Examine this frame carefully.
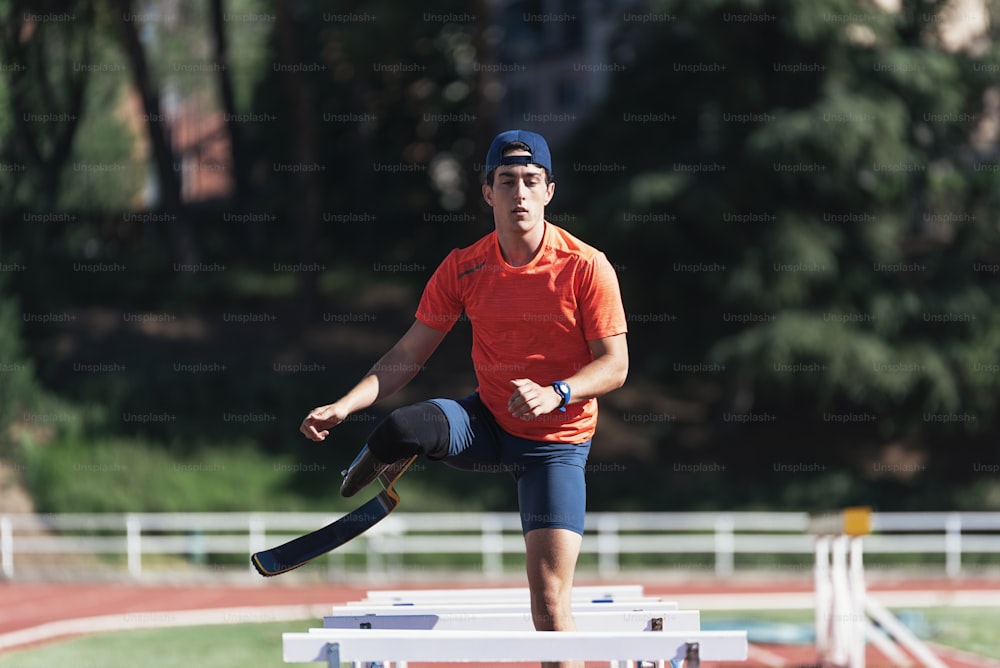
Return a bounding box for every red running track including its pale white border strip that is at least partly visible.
[0,579,1000,668]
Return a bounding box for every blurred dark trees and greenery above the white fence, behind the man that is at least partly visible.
[0,0,1000,536]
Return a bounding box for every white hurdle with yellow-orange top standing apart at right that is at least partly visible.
[809,507,947,668]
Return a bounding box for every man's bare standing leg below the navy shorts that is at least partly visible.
[524,529,583,668]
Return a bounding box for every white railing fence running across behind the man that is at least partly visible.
[0,512,1000,578]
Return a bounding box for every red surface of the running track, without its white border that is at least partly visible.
[0,580,1000,668]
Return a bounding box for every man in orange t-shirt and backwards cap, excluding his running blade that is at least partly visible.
[301,130,628,666]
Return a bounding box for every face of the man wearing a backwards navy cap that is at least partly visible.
[483,151,556,232]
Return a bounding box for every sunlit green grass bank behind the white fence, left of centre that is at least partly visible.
[19,428,516,513]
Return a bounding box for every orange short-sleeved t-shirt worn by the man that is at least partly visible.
[416,222,627,443]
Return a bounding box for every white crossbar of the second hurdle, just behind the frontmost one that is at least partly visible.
[323,608,701,632]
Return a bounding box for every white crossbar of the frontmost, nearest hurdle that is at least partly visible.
[282,629,748,668]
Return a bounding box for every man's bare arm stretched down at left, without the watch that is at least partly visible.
[299,320,447,441]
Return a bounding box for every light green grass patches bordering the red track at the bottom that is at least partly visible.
[0,608,1000,668]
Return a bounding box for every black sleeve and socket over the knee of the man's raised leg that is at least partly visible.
[368,401,451,464]
